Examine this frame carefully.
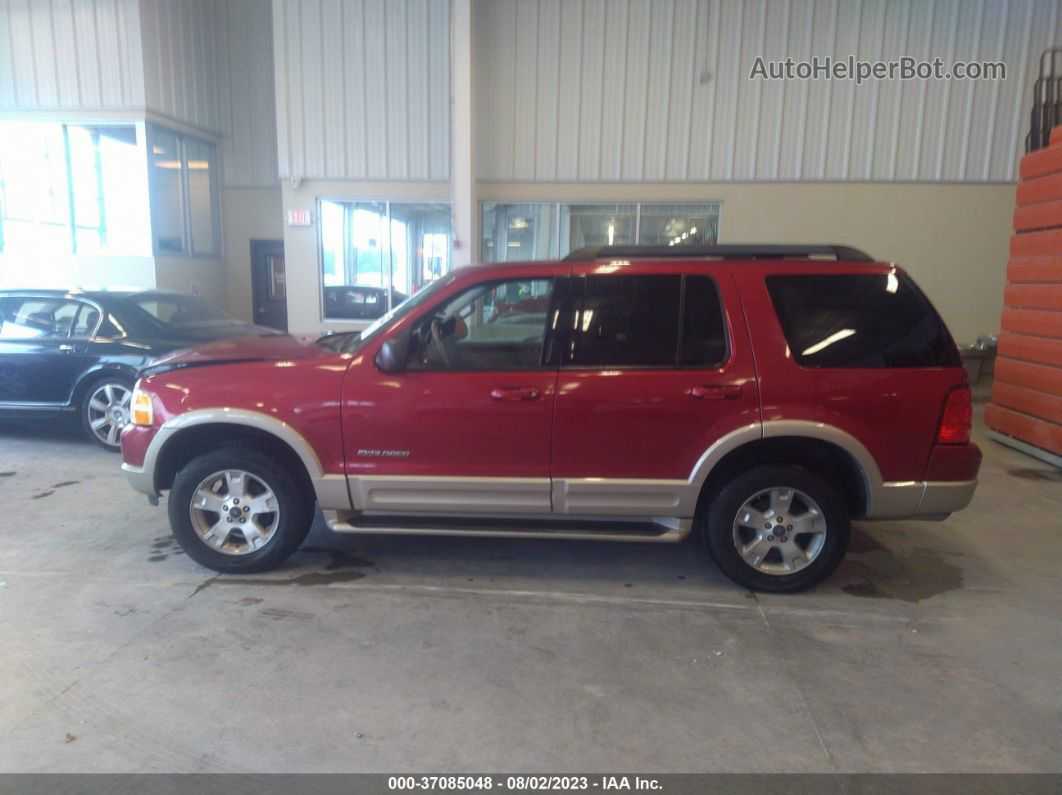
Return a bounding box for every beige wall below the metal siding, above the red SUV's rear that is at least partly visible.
[479,183,1014,343]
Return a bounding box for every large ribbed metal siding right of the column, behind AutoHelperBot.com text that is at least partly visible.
[476,0,1062,182]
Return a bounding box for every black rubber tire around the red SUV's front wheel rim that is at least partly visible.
[167,445,314,574]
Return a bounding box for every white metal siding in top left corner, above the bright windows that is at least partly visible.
[0,0,144,110]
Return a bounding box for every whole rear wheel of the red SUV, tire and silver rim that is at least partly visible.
[705,466,851,592]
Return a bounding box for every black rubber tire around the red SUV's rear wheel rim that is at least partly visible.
[703,466,852,593]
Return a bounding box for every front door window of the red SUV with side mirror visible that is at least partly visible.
[407,279,553,370]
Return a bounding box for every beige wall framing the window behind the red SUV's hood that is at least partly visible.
[284,179,450,333]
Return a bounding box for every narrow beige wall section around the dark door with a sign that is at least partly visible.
[221,186,290,321]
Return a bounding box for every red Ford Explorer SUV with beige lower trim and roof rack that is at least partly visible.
[122,245,981,591]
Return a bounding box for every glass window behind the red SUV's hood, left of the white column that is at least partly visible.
[319,200,453,321]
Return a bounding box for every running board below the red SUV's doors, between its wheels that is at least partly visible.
[323,511,693,542]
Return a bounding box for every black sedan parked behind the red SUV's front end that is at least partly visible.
[0,290,278,451]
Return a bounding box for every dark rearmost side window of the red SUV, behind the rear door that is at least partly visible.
[767,274,959,367]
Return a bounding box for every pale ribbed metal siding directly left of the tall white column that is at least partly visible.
[273,0,450,179]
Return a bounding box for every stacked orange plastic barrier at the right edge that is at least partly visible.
[984,126,1062,456]
